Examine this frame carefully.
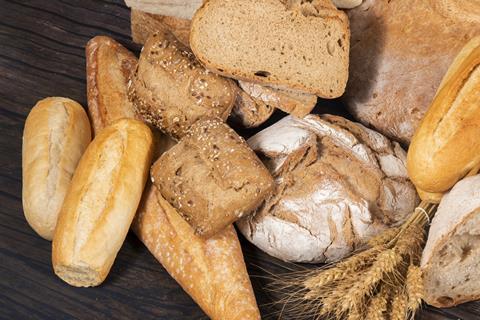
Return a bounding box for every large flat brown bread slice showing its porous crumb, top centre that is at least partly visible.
[190,0,350,98]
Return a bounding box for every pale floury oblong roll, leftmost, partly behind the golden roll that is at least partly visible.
[22,97,91,240]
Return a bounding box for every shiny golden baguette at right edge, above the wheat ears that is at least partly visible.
[407,36,480,200]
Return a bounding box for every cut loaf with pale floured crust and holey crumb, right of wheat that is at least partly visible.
[421,175,480,308]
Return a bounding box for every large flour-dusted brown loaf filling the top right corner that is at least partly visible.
[345,0,480,144]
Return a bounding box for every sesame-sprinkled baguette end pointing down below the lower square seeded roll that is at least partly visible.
[132,185,260,320]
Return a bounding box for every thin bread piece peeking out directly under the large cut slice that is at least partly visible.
[238,81,317,118]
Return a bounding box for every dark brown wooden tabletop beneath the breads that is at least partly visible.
[0,0,480,320]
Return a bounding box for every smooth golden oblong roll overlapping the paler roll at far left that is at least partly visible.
[52,119,153,287]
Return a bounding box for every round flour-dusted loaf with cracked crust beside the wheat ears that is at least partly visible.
[237,115,418,262]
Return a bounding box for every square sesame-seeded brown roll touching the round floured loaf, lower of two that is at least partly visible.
[152,118,273,238]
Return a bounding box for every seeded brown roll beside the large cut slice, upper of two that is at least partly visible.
[129,30,236,139]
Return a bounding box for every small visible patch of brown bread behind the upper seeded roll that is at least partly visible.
[130,9,191,46]
